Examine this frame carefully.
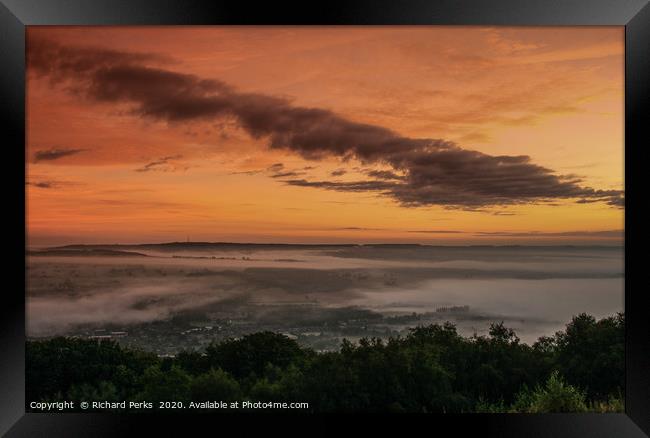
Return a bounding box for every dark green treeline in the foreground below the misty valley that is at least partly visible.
[26,314,625,412]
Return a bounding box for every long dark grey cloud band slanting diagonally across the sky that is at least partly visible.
[28,39,624,209]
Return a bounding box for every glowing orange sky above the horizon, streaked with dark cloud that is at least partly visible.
[26,26,624,245]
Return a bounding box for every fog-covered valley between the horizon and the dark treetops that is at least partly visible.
[27,243,624,354]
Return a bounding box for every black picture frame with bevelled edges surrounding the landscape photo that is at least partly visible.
[0,0,650,437]
